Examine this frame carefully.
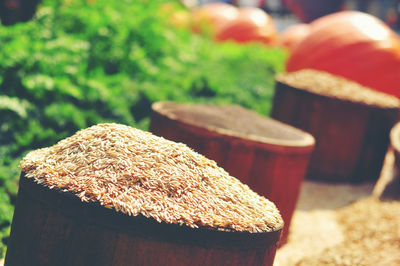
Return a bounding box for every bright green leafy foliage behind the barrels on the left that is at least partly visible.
[0,0,284,257]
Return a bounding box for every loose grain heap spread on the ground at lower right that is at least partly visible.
[297,198,400,266]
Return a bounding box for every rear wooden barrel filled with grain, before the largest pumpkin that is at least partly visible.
[271,70,400,183]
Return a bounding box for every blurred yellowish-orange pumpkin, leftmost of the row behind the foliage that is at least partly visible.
[192,3,238,34]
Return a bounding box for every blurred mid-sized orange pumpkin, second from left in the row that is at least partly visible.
[215,7,278,44]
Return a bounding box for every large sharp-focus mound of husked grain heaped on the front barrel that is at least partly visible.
[21,124,283,233]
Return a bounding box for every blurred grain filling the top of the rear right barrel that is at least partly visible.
[276,69,400,108]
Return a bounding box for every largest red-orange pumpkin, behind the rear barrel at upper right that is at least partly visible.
[286,11,400,97]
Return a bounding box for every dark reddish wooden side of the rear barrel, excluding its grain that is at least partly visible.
[271,81,399,183]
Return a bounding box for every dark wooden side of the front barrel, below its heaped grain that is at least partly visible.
[5,174,281,266]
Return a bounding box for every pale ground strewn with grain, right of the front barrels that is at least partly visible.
[274,181,400,266]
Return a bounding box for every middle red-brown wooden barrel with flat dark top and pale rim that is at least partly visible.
[150,102,314,244]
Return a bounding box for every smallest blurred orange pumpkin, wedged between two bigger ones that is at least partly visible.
[279,23,310,51]
